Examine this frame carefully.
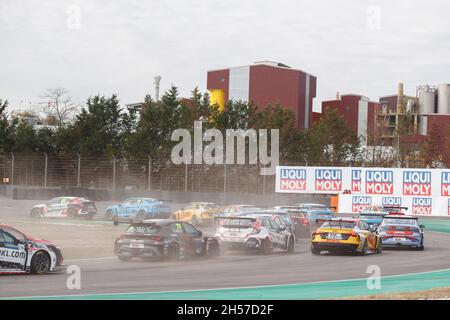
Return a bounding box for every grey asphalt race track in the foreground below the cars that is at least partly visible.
[0,232,450,297]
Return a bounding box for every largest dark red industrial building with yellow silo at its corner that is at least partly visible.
[207,61,317,128]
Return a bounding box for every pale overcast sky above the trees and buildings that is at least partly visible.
[0,0,450,110]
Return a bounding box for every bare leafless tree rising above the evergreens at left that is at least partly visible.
[42,87,81,127]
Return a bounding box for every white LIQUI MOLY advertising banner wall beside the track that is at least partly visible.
[275,166,450,216]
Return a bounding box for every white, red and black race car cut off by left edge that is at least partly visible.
[0,227,58,274]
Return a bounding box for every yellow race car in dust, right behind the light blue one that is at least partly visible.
[174,202,220,226]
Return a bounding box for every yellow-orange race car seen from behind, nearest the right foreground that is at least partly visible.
[311,218,383,256]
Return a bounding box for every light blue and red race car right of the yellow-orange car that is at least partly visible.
[377,215,425,250]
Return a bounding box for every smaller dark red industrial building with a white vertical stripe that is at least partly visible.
[314,93,381,144]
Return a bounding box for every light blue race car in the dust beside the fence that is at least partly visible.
[105,198,172,225]
